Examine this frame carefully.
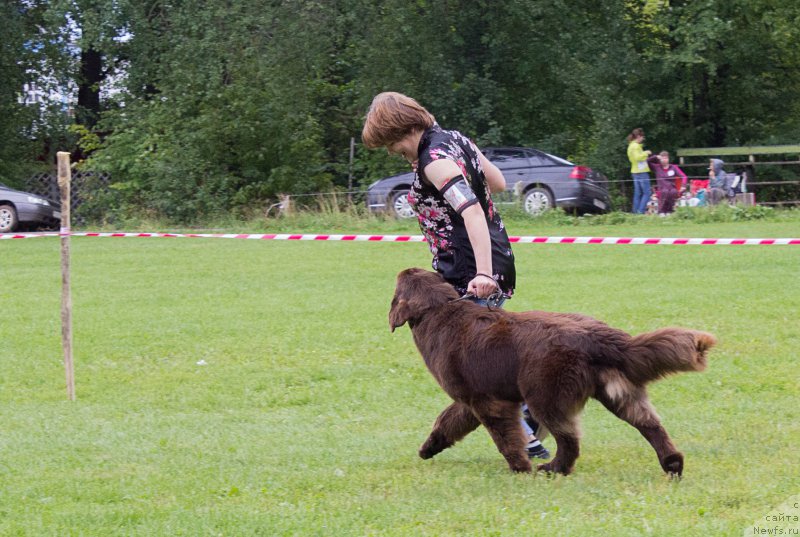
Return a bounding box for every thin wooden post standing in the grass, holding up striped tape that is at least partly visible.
[57,151,75,401]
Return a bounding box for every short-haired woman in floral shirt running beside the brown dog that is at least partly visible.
[362,92,549,458]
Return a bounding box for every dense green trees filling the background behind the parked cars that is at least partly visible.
[0,0,800,222]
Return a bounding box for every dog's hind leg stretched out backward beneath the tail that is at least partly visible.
[595,386,683,477]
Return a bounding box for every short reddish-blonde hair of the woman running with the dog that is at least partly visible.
[361,91,436,148]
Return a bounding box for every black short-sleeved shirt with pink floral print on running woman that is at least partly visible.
[408,125,516,297]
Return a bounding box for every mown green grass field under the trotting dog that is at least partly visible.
[0,216,800,536]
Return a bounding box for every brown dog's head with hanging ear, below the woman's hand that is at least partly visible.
[389,268,458,332]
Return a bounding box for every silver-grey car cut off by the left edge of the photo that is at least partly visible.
[0,183,61,233]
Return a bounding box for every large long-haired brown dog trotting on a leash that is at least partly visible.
[389,268,716,476]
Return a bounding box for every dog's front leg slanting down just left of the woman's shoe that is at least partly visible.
[474,400,531,472]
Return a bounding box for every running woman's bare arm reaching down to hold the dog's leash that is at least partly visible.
[423,159,502,298]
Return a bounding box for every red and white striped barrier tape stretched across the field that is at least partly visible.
[0,232,800,246]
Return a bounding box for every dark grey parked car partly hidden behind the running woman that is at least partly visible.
[367,147,611,218]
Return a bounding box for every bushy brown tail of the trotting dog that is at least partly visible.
[623,328,717,386]
